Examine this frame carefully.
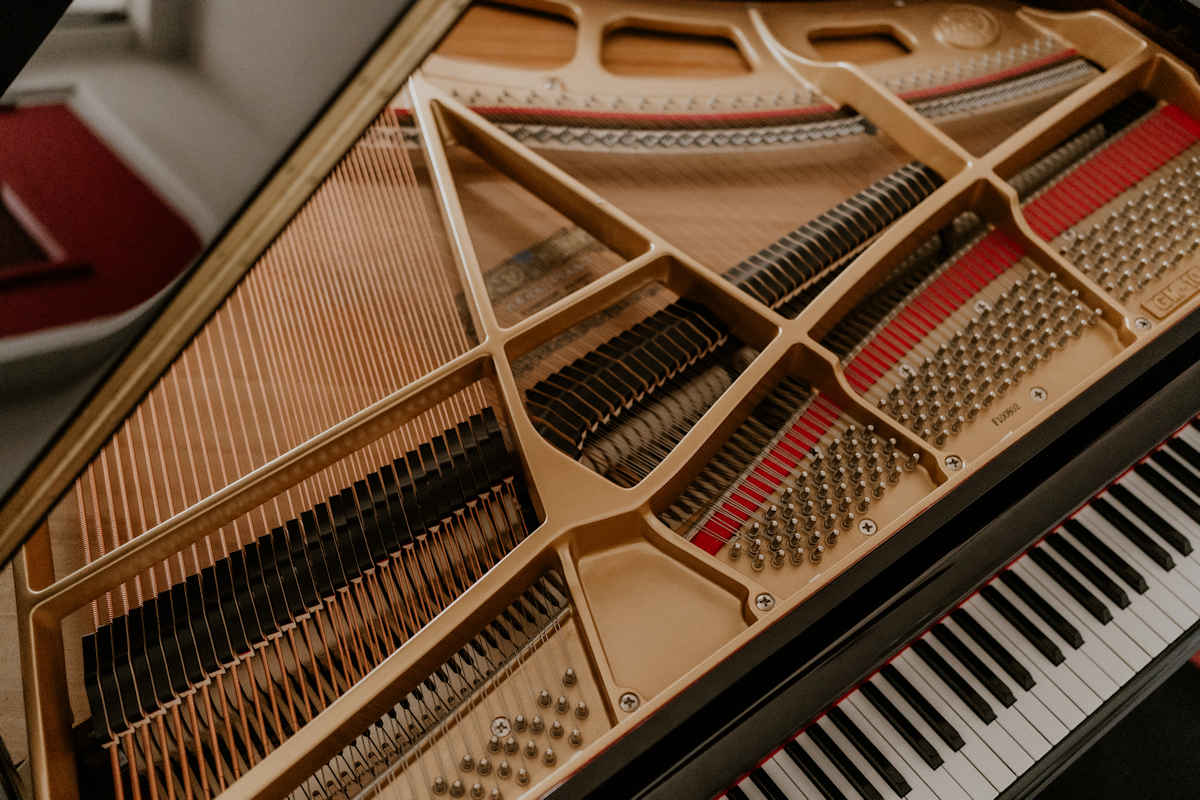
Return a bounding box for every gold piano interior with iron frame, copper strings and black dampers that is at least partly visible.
[7,0,1200,800]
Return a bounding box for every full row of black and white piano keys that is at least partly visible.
[719,420,1200,800]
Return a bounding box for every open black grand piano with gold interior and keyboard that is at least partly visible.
[0,0,1200,800]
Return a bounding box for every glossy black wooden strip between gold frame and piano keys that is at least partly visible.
[550,314,1200,800]
